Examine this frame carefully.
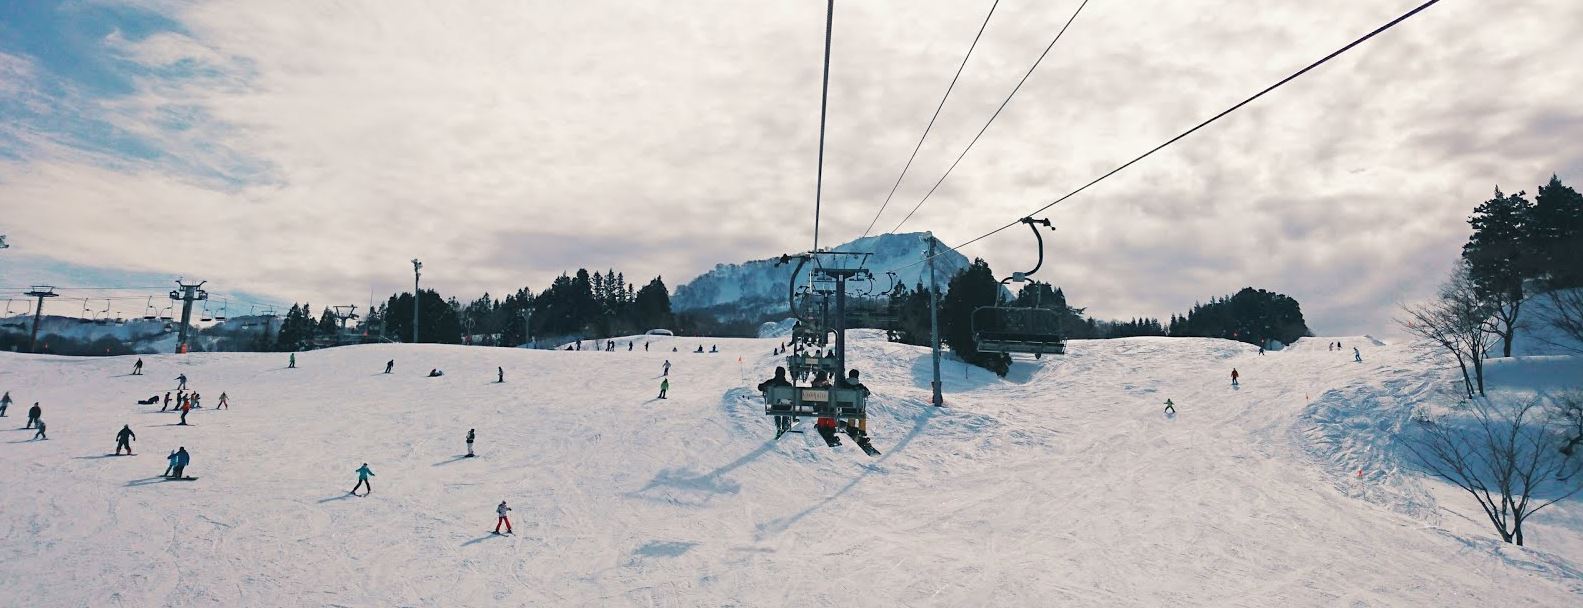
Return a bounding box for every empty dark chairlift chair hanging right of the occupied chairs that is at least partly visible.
[972,217,1067,358]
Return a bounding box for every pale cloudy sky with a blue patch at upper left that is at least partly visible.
[0,0,1583,334]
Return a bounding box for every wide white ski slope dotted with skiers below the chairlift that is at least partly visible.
[0,331,1583,606]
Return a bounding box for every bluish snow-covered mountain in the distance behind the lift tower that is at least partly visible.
[671,233,967,318]
